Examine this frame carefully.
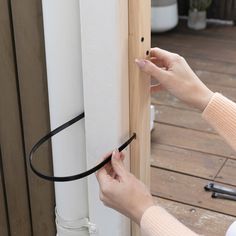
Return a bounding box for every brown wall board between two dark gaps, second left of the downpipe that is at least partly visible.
[0,0,32,236]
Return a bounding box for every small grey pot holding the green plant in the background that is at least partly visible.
[188,10,206,30]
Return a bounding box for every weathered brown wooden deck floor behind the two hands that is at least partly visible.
[151,22,236,236]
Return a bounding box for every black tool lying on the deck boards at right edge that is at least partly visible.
[204,183,236,201]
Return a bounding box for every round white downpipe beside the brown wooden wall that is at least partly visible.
[42,0,91,236]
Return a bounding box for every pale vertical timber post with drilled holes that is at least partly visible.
[129,0,151,236]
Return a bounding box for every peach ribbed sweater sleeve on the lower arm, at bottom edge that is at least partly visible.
[140,206,197,236]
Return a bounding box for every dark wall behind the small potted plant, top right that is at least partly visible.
[178,0,236,21]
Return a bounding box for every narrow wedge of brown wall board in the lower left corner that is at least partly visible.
[0,148,9,236]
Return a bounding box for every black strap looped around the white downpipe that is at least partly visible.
[29,113,136,182]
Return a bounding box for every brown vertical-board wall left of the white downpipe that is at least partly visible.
[0,0,55,236]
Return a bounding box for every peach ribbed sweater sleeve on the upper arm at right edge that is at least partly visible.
[202,93,236,150]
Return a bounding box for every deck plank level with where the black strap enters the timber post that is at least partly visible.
[152,123,236,158]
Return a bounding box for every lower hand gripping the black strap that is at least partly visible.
[96,151,154,224]
